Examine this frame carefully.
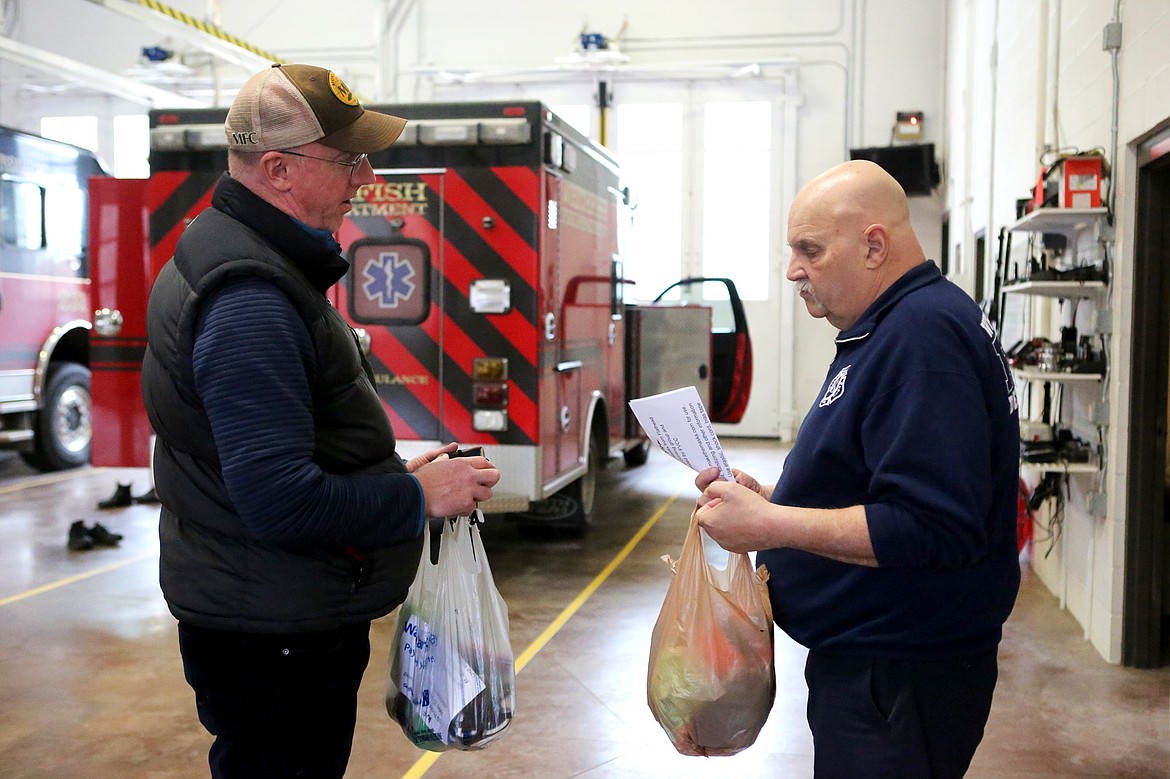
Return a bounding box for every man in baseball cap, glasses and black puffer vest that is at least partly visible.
[143,64,500,779]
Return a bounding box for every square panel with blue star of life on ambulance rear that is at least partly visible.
[350,241,429,324]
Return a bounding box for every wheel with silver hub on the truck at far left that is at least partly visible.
[23,363,94,470]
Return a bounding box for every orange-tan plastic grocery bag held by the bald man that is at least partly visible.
[646,502,776,756]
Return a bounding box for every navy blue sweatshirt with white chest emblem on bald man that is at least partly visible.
[757,261,1019,659]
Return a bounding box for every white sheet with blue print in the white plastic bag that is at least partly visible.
[398,614,486,744]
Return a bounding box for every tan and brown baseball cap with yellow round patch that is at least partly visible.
[223,64,406,154]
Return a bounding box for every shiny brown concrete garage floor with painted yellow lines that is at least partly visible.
[0,440,1170,779]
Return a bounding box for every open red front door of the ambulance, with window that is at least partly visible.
[654,277,752,423]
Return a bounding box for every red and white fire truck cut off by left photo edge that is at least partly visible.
[0,127,105,470]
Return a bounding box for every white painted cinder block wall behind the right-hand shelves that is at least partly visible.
[945,0,1170,662]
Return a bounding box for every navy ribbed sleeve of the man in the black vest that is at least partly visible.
[193,281,424,547]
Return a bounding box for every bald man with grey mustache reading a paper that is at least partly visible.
[695,160,1020,779]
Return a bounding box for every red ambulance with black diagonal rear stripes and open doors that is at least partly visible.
[92,102,751,531]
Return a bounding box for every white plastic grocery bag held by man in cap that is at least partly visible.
[386,510,516,752]
